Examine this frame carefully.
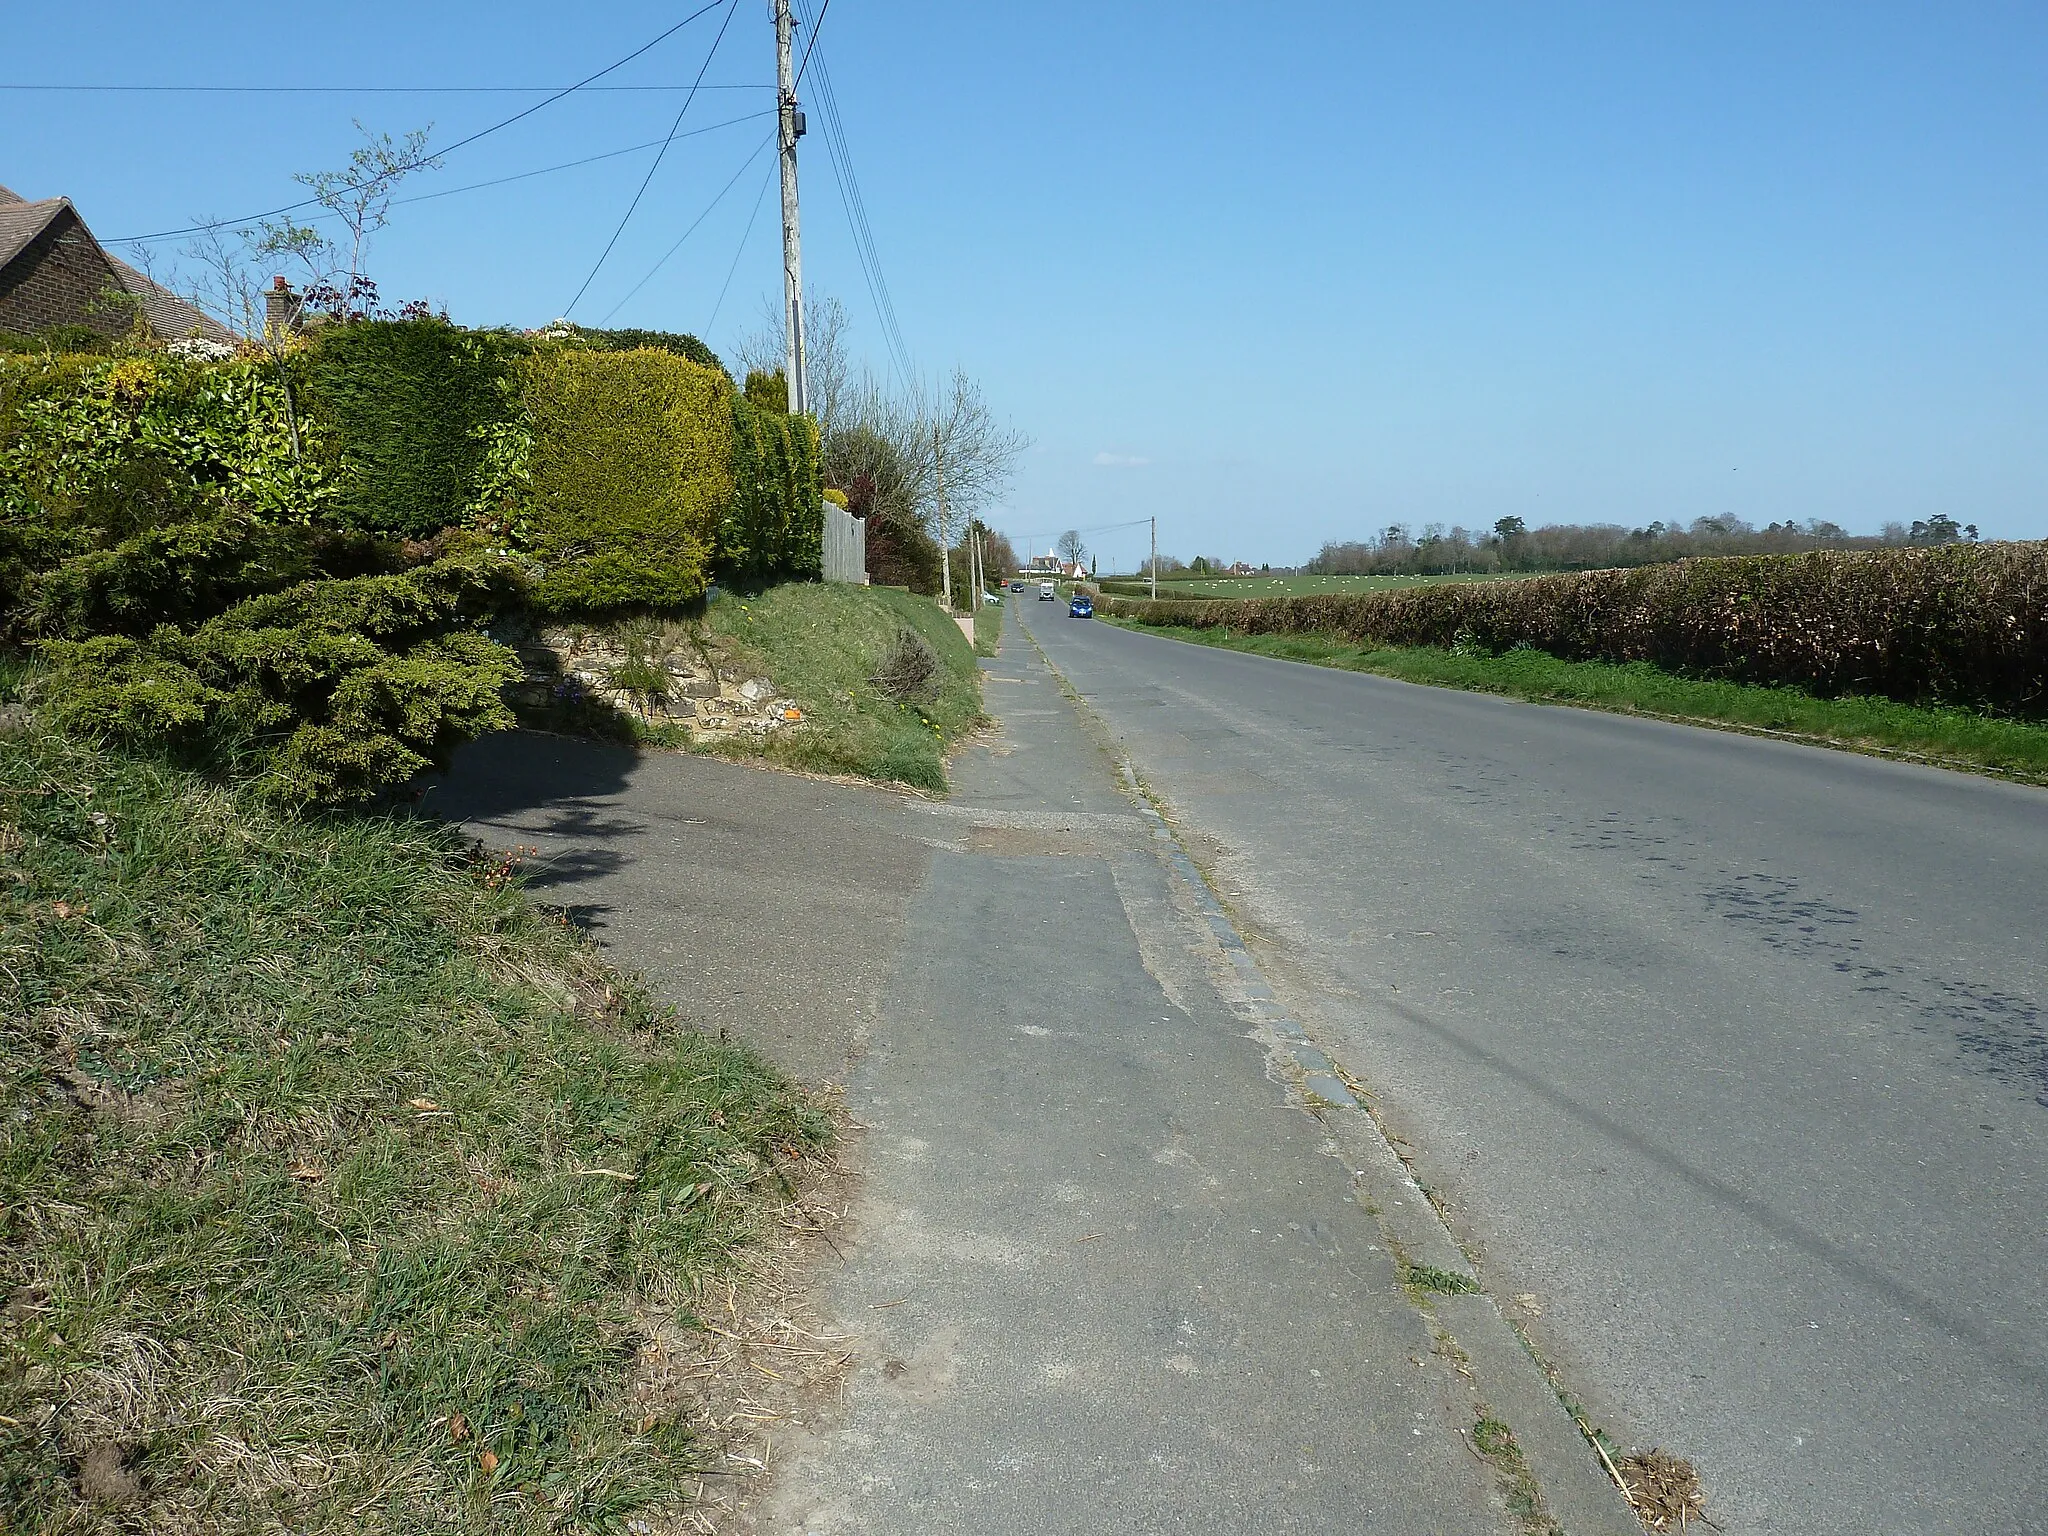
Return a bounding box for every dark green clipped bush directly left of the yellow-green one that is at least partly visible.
[309,319,526,539]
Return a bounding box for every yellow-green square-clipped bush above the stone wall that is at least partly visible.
[518,348,733,614]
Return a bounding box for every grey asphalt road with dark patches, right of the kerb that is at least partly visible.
[1018,602,2048,1536]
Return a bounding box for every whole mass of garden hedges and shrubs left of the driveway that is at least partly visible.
[0,331,823,805]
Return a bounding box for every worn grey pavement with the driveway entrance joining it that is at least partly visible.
[434,606,1632,1536]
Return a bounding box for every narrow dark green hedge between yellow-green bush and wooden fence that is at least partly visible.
[719,395,825,586]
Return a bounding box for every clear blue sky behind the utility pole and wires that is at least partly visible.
[0,0,2048,563]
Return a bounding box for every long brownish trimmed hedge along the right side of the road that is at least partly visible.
[1104,543,2048,715]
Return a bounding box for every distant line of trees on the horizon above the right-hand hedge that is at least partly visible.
[1303,512,1976,575]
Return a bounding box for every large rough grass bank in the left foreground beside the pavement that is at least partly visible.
[0,729,827,1534]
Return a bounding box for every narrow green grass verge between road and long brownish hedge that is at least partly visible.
[1104,618,2048,784]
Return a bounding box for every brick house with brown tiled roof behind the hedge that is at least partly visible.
[0,186,233,342]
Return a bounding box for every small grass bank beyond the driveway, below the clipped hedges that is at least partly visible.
[707,582,981,791]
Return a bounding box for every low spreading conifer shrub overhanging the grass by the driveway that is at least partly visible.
[41,557,520,805]
